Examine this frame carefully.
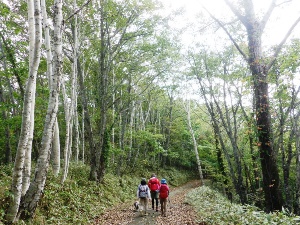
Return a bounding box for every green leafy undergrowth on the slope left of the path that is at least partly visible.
[0,164,195,225]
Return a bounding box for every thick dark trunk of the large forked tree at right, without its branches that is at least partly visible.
[247,27,282,212]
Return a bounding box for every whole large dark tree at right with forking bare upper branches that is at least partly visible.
[204,0,300,212]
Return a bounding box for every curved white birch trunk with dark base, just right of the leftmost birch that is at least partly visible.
[18,0,62,219]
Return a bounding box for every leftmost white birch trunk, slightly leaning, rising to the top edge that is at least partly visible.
[6,0,42,223]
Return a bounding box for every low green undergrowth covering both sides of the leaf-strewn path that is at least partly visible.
[4,164,300,225]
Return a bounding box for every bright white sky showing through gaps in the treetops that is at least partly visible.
[157,0,300,100]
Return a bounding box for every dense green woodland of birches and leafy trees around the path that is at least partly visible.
[0,0,300,224]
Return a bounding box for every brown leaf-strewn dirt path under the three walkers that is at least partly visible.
[93,181,201,225]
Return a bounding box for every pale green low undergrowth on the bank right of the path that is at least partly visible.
[186,186,300,225]
